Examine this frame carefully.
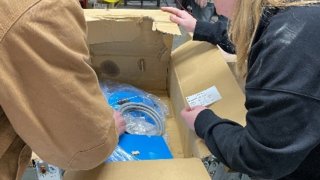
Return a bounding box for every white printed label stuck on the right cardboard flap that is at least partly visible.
[186,86,222,108]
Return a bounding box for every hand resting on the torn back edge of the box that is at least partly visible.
[161,7,197,32]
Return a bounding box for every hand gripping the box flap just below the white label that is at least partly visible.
[181,106,207,131]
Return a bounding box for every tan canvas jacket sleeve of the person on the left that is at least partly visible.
[0,0,118,170]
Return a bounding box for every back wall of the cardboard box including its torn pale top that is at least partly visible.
[84,9,180,91]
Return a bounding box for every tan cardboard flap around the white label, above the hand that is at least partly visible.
[172,41,246,125]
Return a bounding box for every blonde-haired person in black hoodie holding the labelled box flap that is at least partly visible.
[181,0,320,180]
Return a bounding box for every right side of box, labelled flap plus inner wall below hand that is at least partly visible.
[170,41,246,157]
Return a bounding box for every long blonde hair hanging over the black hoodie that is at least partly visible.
[229,0,320,77]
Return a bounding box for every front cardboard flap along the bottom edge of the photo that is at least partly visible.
[64,158,210,180]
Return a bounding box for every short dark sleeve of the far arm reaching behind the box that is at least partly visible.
[193,16,235,54]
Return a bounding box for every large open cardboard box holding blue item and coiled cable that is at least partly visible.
[64,9,246,180]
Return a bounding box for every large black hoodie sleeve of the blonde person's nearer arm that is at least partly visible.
[195,8,320,179]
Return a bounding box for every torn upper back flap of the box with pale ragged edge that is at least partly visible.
[85,9,181,44]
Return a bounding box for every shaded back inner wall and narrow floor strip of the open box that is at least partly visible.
[88,10,185,158]
